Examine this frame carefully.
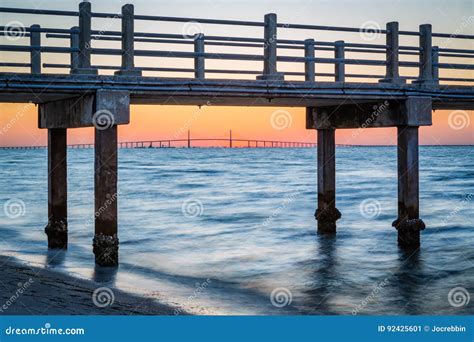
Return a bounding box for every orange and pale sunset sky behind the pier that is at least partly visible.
[0,0,474,146]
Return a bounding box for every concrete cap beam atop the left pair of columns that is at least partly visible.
[39,90,130,128]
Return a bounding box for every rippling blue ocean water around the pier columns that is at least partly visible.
[0,146,474,315]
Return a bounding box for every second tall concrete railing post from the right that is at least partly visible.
[380,21,405,84]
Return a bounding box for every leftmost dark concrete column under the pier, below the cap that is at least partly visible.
[44,128,67,249]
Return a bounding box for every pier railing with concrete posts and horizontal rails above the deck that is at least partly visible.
[0,2,474,87]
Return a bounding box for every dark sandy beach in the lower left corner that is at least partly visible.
[0,255,183,315]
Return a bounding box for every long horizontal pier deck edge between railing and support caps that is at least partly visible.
[0,73,474,110]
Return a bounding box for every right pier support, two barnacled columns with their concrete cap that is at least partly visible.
[306,96,432,249]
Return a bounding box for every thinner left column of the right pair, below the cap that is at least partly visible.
[314,129,341,233]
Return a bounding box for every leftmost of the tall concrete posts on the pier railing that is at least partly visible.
[71,1,97,75]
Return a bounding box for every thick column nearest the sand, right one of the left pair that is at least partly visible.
[93,125,119,266]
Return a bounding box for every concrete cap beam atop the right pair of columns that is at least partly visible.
[306,97,432,129]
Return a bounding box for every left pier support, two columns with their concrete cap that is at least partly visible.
[38,89,130,266]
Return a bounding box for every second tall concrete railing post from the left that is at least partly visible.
[115,4,142,76]
